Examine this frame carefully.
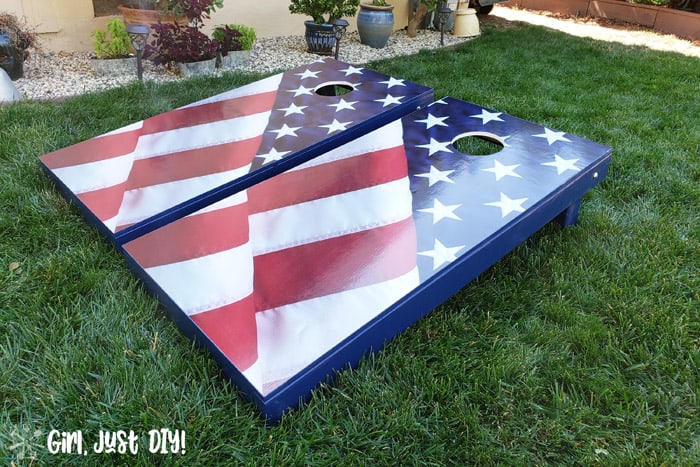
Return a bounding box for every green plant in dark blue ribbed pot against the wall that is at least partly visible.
[289,0,360,55]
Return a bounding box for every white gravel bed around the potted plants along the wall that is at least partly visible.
[14,30,468,99]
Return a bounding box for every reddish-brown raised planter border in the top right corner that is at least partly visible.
[509,0,700,40]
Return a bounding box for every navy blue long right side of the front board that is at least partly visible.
[258,149,612,424]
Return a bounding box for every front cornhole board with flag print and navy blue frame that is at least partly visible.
[38,61,611,422]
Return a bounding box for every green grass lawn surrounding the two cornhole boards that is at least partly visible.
[0,20,700,465]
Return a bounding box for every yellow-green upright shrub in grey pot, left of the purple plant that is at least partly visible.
[91,18,136,76]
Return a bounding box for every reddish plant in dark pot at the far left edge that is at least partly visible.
[0,13,39,81]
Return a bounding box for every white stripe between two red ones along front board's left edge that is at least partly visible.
[145,243,253,315]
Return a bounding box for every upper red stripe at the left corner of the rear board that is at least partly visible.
[39,130,141,170]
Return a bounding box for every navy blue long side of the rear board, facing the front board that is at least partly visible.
[115,88,434,245]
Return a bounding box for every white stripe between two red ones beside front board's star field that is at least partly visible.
[249,178,412,255]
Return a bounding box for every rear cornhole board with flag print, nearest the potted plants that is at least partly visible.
[40,59,433,244]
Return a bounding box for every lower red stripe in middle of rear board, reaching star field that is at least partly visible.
[127,135,262,190]
